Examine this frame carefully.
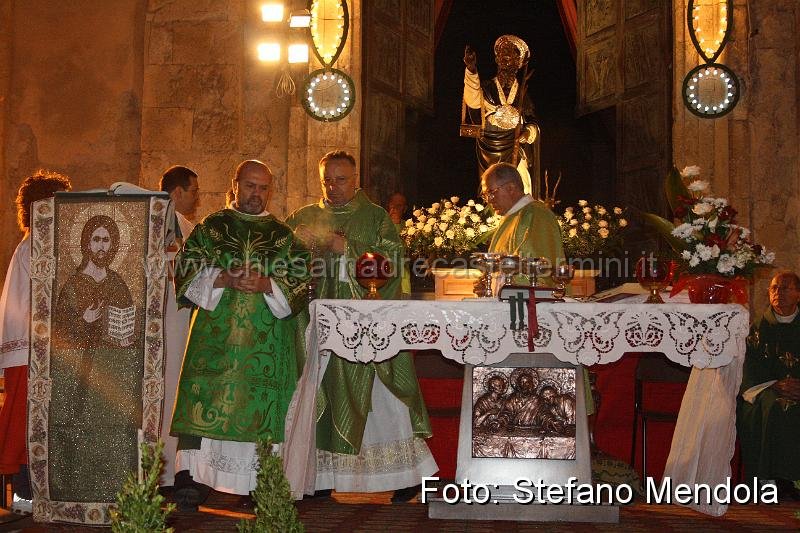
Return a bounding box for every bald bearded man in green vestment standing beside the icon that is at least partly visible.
[172,161,309,508]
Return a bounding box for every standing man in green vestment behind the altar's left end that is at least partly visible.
[286,151,438,501]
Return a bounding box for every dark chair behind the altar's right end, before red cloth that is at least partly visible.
[631,353,692,479]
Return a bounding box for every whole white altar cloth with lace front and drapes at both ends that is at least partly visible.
[284,296,749,515]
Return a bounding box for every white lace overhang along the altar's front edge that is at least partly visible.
[312,299,749,368]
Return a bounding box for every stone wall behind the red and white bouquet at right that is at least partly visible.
[673,0,800,310]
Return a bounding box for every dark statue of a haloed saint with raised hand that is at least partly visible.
[464,35,540,197]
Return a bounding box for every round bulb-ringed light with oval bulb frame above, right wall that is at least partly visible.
[682,0,739,118]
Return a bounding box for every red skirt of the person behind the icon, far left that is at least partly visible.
[0,366,28,474]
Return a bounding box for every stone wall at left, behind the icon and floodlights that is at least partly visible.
[0,0,361,271]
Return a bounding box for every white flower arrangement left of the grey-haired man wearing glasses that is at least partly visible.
[400,196,500,257]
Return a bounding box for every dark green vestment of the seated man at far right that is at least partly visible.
[736,307,800,480]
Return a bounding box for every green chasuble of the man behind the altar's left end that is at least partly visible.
[286,190,431,455]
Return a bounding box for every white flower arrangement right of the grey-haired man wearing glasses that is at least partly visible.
[557,200,628,258]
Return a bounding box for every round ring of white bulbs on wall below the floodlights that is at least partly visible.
[302,68,356,122]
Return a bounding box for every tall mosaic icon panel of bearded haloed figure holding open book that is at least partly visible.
[28,193,172,525]
